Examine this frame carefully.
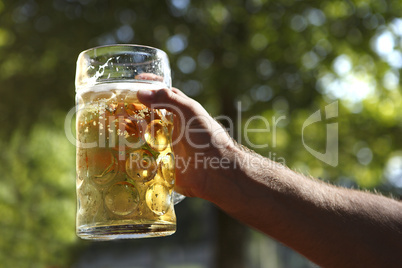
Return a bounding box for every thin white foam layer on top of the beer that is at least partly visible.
[76,81,167,93]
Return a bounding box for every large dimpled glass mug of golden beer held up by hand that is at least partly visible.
[75,45,182,240]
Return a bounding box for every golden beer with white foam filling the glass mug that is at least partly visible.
[76,81,176,239]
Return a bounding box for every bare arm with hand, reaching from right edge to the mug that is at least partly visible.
[139,89,402,267]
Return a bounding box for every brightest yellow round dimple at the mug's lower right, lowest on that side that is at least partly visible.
[145,184,172,216]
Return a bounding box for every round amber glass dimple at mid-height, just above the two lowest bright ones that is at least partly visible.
[126,149,157,181]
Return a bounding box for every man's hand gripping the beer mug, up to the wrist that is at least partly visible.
[137,88,234,198]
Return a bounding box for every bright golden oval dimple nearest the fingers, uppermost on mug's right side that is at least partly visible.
[144,120,169,151]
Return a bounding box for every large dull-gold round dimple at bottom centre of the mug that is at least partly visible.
[105,182,139,216]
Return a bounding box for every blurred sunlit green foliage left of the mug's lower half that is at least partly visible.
[0,122,76,267]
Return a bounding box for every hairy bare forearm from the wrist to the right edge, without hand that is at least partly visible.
[205,149,402,267]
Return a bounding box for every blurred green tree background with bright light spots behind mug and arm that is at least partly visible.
[0,0,402,268]
